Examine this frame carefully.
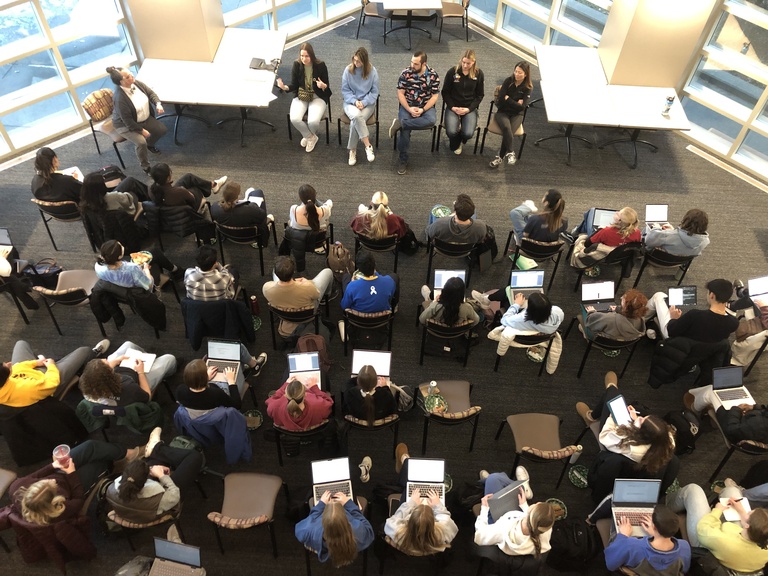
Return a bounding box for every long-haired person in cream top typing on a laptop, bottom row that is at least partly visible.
[384,444,459,556]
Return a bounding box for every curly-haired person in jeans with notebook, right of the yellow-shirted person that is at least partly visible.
[80,342,176,406]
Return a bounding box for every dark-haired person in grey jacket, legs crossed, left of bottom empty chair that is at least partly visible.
[107,428,204,523]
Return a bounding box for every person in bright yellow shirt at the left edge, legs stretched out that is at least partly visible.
[0,340,109,408]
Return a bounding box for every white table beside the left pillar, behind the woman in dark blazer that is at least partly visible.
[137,28,287,146]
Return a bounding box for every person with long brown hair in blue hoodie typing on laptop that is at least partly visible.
[295,491,375,568]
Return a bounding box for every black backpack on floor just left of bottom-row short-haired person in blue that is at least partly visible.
[547,518,603,572]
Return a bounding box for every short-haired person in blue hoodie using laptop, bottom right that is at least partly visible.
[605,504,691,576]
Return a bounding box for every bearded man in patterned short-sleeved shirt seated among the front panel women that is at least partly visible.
[389,51,440,175]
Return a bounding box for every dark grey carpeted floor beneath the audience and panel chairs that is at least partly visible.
[0,15,768,575]
